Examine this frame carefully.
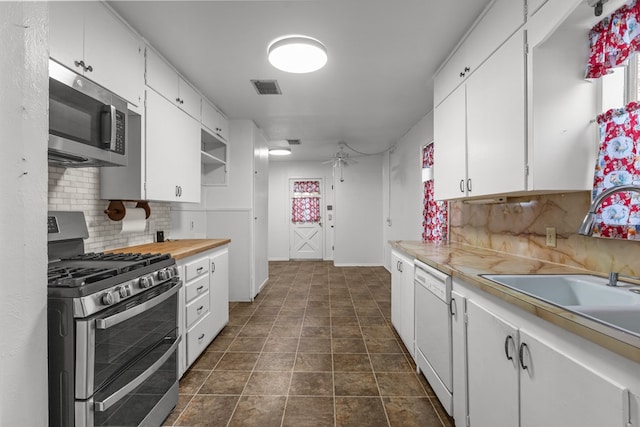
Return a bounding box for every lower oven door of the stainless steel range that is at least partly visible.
[94,340,178,426]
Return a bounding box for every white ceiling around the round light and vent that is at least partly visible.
[109,0,490,160]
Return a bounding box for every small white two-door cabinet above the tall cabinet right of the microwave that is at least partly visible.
[146,48,201,121]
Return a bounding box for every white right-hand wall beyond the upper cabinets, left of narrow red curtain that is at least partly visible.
[383,112,437,269]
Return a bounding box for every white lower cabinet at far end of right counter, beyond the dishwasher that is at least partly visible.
[391,250,416,360]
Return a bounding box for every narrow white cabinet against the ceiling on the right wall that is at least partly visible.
[434,0,524,105]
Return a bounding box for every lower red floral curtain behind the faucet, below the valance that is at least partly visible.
[592,102,640,240]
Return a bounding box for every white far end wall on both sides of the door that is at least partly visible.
[269,156,383,265]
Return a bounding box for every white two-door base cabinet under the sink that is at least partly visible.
[453,281,640,427]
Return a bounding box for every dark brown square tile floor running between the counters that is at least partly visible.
[165,261,453,427]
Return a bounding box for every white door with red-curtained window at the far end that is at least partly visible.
[289,178,324,259]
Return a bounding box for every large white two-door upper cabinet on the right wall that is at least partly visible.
[434,30,526,200]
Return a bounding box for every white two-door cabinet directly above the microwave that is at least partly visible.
[49,2,144,106]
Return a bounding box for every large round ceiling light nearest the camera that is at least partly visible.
[268,35,327,74]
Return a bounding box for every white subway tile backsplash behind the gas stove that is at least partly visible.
[48,166,170,252]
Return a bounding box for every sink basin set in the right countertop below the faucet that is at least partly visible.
[483,274,640,336]
